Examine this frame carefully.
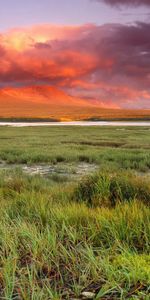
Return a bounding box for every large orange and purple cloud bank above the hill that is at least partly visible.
[0,23,150,109]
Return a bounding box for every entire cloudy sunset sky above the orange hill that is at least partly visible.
[0,0,150,109]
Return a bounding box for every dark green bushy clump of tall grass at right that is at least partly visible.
[73,173,150,207]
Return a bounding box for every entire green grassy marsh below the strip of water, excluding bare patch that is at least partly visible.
[0,126,150,300]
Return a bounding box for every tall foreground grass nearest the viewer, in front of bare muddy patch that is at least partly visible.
[0,171,150,300]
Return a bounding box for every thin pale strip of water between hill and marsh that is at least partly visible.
[0,121,150,127]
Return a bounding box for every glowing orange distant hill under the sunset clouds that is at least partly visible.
[0,86,150,121]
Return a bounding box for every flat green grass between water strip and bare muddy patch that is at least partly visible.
[0,126,150,172]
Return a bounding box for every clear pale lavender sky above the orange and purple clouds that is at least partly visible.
[0,0,149,30]
